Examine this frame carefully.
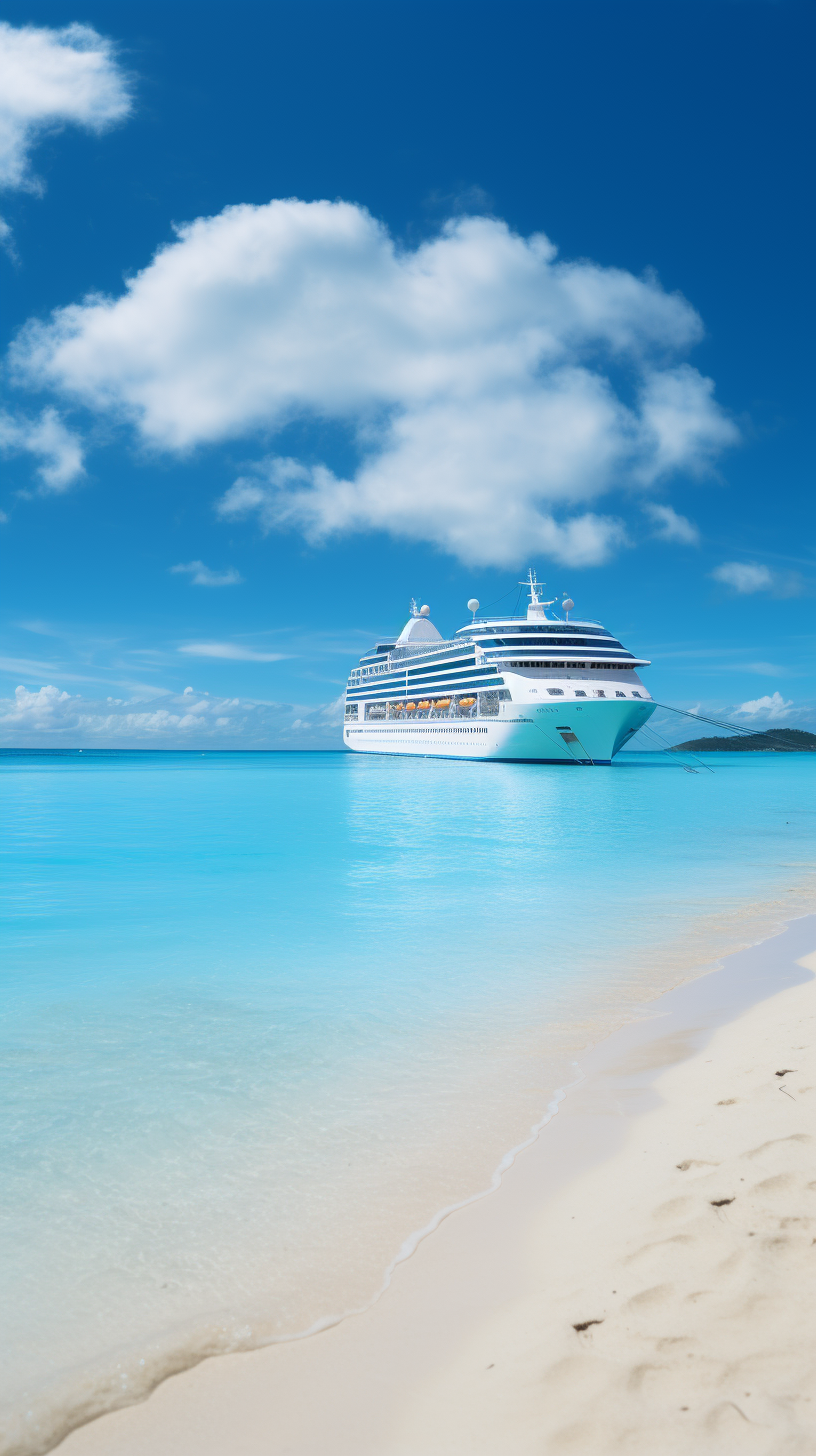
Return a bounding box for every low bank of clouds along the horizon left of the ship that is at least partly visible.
[0,684,342,748]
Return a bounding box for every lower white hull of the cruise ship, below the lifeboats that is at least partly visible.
[344,697,654,764]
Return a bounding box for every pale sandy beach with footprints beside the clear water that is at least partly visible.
[60,916,816,1456]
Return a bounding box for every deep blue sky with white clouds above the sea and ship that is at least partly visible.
[0,0,816,747]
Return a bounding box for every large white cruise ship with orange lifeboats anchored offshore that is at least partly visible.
[342,571,656,766]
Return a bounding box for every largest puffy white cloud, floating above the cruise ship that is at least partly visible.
[13,199,737,565]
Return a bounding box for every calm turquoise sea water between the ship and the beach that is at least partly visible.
[0,753,816,1452]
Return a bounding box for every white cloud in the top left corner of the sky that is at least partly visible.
[0,20,131,189]
